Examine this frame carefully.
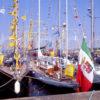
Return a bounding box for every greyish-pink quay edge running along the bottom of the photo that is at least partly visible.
[7,91,100,100]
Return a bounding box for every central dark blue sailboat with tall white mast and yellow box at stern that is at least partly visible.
[29,0,79,89]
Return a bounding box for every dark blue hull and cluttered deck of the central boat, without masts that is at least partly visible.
[30,50,79,89]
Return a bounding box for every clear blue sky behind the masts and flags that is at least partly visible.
[0,0,100,49]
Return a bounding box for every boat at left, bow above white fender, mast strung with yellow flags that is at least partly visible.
[0,0,28,80]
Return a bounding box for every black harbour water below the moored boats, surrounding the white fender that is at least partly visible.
[0,74,100,99]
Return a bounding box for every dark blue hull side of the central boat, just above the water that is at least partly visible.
[32,72,79,89]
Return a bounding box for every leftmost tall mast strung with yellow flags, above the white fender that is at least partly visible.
[10,0,20,70]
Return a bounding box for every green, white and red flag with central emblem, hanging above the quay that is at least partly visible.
[76,38,94,92]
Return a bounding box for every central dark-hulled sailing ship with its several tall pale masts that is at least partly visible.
[30,0,79,89]
